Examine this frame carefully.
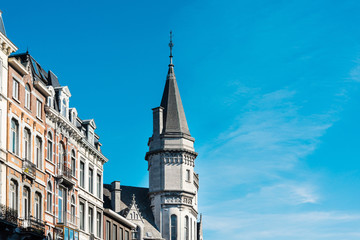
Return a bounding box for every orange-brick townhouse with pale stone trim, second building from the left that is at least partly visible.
[6,51,49,239]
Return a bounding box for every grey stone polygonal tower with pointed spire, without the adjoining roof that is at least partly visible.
[145,32,199,240]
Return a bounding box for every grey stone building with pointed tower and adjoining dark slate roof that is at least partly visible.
[104,33,203,240]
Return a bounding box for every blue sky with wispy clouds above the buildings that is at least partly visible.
[0,0,360,240]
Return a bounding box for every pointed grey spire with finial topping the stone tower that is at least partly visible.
[160,32,190,135]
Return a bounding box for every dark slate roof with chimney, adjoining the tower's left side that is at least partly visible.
[104,184,162,239]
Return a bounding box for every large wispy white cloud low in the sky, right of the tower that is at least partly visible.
[199,87,360,240]
